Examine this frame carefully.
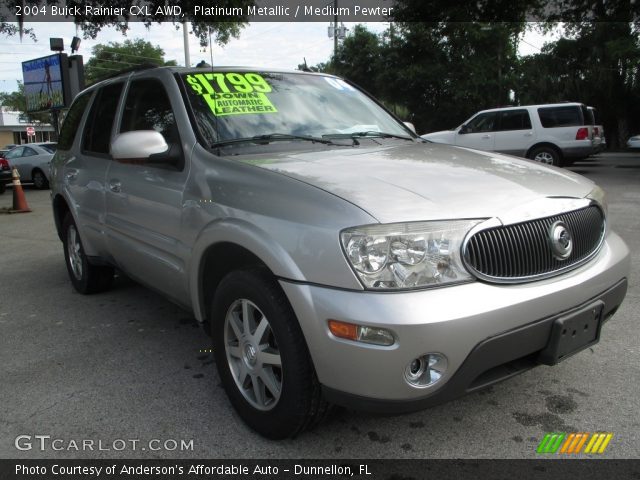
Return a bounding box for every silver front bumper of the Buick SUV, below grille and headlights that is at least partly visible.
[280,233,629,412]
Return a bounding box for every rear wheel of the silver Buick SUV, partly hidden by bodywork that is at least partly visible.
[62,214,114,295]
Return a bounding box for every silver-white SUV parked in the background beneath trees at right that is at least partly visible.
[422,103,595,166]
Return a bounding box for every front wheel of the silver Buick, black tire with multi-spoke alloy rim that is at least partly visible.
[211,269,328,440]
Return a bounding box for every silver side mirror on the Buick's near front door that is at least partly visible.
[111,130,169,163]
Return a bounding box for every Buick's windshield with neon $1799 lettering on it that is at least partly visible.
[182,71,410,146]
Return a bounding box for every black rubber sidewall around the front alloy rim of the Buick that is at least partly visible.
[211,271,310,439]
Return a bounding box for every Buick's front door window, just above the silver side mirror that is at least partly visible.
[120,79,180,144]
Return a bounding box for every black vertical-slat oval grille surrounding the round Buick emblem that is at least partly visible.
[464,205,605,282]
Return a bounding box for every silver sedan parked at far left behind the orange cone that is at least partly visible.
[5,143,57,189]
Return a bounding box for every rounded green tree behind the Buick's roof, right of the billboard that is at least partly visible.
[84,39,176,84]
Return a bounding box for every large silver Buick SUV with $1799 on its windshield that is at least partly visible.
[51,67,629,438]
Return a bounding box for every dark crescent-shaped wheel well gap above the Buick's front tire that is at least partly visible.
[199,242,272,333]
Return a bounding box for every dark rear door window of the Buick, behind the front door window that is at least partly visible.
[82,83,123,155]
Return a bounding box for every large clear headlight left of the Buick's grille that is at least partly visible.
[340,220,482,290]
